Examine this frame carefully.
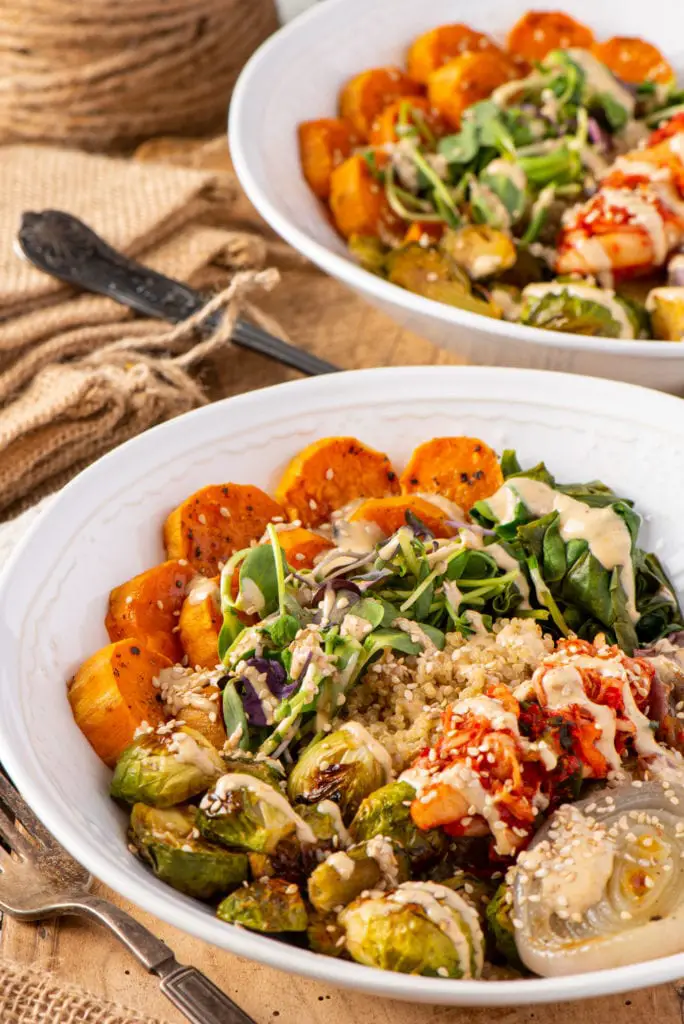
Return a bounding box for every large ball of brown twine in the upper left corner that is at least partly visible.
[0,0,277,148]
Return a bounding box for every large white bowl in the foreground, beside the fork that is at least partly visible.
[0,367,684,1006]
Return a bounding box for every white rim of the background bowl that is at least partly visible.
[227,0,684,359]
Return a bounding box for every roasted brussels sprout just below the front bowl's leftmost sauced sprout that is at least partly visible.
[128,804,249,899]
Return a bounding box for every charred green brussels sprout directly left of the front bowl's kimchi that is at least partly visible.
[349,782,448,868]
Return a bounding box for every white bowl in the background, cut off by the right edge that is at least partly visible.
[229,0,684,394]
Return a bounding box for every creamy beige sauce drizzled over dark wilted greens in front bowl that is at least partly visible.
[487,476,639,622]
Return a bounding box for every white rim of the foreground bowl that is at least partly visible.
[0,367,684,1007]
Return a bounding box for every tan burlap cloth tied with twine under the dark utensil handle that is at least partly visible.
[0,139,296,518]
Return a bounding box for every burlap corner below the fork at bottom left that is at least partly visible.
[0,961,163,1024]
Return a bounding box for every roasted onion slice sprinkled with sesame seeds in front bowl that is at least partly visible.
[512,780,684,977]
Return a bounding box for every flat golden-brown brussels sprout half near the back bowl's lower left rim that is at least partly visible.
[387,243,500,317]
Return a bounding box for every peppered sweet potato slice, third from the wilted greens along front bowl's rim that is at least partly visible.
[164,483,285,577]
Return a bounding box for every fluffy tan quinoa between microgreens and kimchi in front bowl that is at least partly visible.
[346,618,553,772]
